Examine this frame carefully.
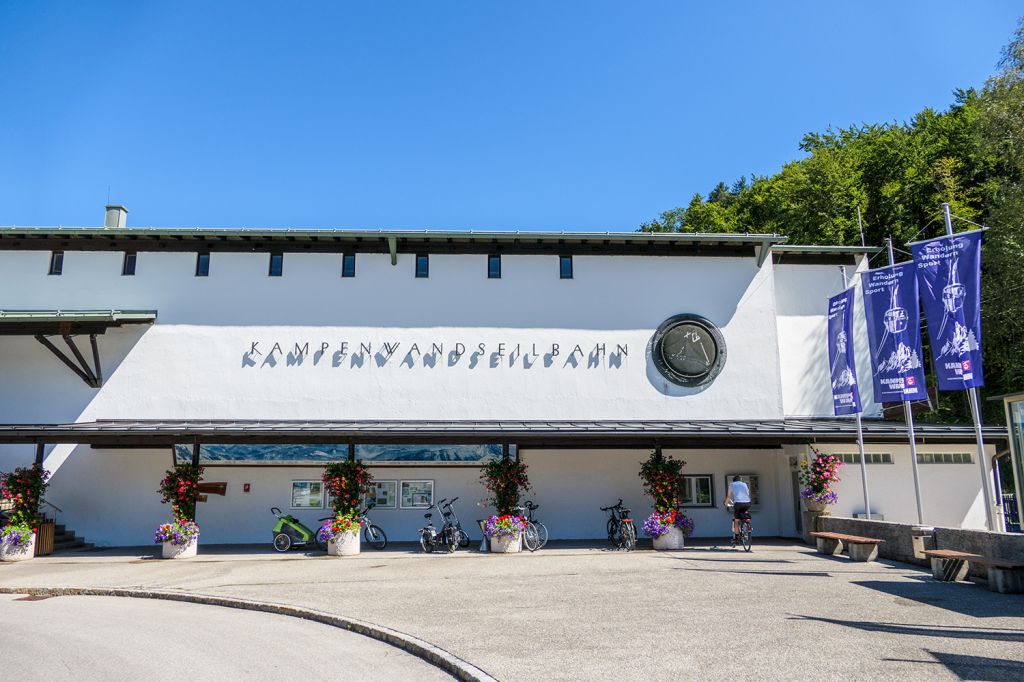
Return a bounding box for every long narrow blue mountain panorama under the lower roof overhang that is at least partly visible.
[174,443,502,463]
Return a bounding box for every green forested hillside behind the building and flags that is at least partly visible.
[640,18,1024,424]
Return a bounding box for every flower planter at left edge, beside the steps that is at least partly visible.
[0,464,50,561]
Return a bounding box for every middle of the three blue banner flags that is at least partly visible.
[860,263,926,402]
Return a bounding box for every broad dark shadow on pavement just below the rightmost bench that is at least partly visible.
[852,580,1024,619]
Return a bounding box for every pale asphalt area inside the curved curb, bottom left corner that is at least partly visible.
[0,594,453,682]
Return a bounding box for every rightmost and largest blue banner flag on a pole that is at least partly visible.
[910,229,985,391]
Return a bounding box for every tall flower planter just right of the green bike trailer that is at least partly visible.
[316,460,374,556]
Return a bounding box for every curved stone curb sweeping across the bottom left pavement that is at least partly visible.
[0,587,498,682]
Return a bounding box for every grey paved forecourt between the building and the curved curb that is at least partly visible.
[0,542,1024,681]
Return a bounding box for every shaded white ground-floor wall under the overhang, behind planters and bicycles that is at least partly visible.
[46,446,793,546]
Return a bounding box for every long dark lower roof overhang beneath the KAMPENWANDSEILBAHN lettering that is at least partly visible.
[0,418,1007,447]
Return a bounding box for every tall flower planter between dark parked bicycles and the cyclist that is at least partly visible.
[640,447,693,551]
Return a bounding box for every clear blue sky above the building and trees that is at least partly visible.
[0,0,1024,231]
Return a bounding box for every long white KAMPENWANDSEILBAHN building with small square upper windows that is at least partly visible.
[0,207,1006,545]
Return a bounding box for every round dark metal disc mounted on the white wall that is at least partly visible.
[651,314,726,388]
